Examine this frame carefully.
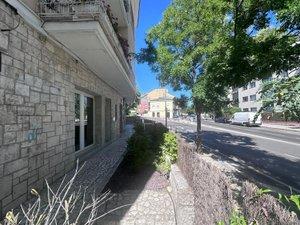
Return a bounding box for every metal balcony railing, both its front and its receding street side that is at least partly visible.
[38,0,131,79]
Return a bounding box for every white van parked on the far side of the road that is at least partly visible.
[231,112,261,126]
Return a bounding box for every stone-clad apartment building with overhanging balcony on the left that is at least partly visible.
[0,0,139,217]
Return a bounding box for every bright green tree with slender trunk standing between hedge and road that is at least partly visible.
[137,0,227,148]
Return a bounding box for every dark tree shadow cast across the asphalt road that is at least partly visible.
[180,131,300,193]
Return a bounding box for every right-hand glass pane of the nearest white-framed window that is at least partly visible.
[84,96,94,147]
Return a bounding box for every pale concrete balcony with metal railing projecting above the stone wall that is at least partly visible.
[38,0,135,99]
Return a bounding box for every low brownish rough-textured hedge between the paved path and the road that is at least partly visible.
[177,138,300,225]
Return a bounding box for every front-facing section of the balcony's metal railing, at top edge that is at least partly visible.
[39,0,106,19]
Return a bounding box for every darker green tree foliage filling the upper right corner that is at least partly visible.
[206,0,300,86]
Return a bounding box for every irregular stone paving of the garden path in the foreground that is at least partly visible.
[97,188,176,225]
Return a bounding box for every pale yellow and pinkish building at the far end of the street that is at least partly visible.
[138,88,175,118]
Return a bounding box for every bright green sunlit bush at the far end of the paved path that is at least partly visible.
[155,132,178,173]
